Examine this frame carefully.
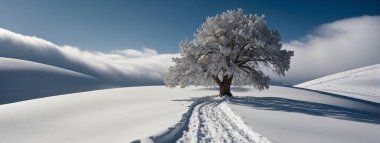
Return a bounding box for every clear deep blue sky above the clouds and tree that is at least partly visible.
[0,0,380,53]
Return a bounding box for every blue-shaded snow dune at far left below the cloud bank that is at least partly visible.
[0,57,111,104]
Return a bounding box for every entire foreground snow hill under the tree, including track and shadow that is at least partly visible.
[0,86,380,143]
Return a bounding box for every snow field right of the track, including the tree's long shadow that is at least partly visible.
[224,87,380,143]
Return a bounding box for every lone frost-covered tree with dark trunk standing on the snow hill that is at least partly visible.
[164,9,293,96]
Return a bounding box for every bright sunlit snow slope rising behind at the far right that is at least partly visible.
[295,64,380,103]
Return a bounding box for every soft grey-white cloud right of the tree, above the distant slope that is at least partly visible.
[275,16,380,83]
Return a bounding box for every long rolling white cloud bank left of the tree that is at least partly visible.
[0,28,178,86]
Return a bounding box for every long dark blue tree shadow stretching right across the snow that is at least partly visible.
[229,97,380,124]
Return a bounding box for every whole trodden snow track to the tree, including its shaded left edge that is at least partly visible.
[151,97,269,143]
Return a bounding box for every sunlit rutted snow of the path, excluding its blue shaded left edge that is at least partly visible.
[178,99,269,143]
